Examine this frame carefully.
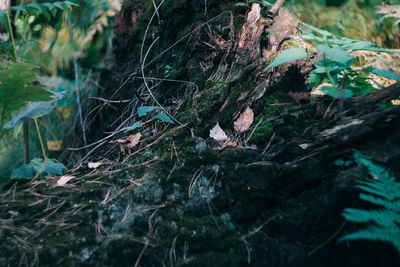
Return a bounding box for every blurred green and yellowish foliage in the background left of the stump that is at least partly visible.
[0,0,120,180]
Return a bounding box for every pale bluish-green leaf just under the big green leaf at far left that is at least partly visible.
[4,101,54,129]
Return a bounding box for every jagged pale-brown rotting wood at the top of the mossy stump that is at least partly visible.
[219,1,313,119]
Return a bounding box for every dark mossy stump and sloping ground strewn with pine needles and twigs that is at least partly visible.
[0,0,400,266]
